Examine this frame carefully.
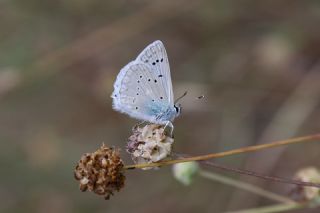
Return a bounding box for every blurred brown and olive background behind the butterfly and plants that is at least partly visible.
[0,0,320,213]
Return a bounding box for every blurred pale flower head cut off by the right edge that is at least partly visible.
[292,167,320,201]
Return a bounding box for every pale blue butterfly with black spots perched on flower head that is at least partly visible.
[111,41,181,127]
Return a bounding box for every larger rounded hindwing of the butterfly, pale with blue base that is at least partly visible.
[111,61,169,123]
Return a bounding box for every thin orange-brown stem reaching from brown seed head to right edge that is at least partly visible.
[124,134,320,169]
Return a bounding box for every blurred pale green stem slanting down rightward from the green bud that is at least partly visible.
[199,170,296,204]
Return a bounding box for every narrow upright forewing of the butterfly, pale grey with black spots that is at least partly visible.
[136,40,174,105]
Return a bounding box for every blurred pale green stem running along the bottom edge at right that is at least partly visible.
[228,203,306,213]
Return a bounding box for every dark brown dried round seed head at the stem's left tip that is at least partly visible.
[74,144,125,200]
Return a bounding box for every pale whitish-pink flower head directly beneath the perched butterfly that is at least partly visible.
[127,124,174,167]
